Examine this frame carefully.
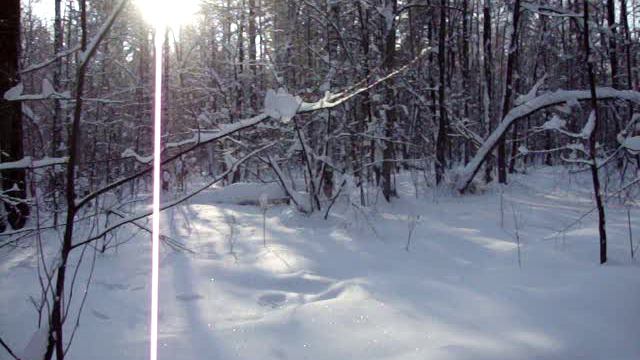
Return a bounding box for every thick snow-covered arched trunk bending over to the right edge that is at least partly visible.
[456,87,640,193]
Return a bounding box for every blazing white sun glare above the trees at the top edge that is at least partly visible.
[136,0,201,30]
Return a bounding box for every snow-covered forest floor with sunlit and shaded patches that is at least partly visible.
[0,168,640,360]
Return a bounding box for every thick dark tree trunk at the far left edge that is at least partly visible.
[0,0,29,231]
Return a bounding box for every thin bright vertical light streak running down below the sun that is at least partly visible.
[149,24,164,360]
